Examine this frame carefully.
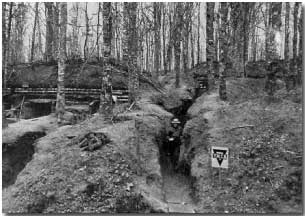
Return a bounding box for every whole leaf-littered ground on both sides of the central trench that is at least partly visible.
[2,67,303,213]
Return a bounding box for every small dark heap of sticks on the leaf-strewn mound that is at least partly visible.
[79,132,110,152]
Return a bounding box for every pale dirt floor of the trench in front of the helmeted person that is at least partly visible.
[161,156,195,213]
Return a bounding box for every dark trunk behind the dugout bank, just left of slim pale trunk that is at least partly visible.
[44,2,53,62]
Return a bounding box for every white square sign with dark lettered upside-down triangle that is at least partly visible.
[211,146,229,169]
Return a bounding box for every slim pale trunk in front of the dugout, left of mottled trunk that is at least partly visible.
[56,3,67,124]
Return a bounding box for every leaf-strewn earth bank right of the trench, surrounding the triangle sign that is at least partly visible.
[180,79,302,213]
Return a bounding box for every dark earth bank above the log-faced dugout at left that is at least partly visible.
[8,63,127,88]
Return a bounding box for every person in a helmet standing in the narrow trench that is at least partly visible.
[164,118,182,167]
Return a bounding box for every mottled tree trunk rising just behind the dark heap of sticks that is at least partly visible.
[99,2,112,116]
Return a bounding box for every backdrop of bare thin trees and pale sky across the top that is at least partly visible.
[2,2,303,76]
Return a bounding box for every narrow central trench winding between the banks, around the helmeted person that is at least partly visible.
[159,100,195,213]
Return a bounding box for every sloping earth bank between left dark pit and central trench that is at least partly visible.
[2,90,172,213]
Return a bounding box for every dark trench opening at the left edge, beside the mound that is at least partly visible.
[2,132,46,188]
